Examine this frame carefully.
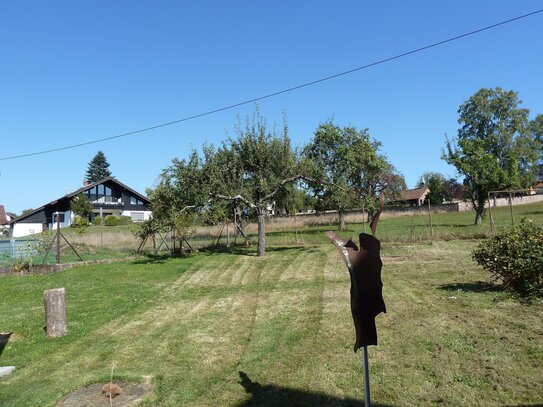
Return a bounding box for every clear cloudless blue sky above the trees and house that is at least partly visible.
[0,0,543,213]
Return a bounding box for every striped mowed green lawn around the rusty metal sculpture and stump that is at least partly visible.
[0,240,543,407]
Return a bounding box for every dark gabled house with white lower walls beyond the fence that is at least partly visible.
[9,177,151,237]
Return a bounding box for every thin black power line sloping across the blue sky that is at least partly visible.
[0,9,543,161]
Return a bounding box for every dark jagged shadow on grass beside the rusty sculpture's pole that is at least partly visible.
[237,372,392,407]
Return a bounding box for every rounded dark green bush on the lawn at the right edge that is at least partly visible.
[472,219,543,296]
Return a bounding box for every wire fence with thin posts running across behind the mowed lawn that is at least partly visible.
[0,191,543,267]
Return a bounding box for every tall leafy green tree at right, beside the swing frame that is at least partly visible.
[442,87,532,224]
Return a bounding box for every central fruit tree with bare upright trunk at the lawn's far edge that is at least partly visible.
[204,109,304,256]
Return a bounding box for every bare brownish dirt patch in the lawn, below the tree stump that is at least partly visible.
[56,381,151,407]
